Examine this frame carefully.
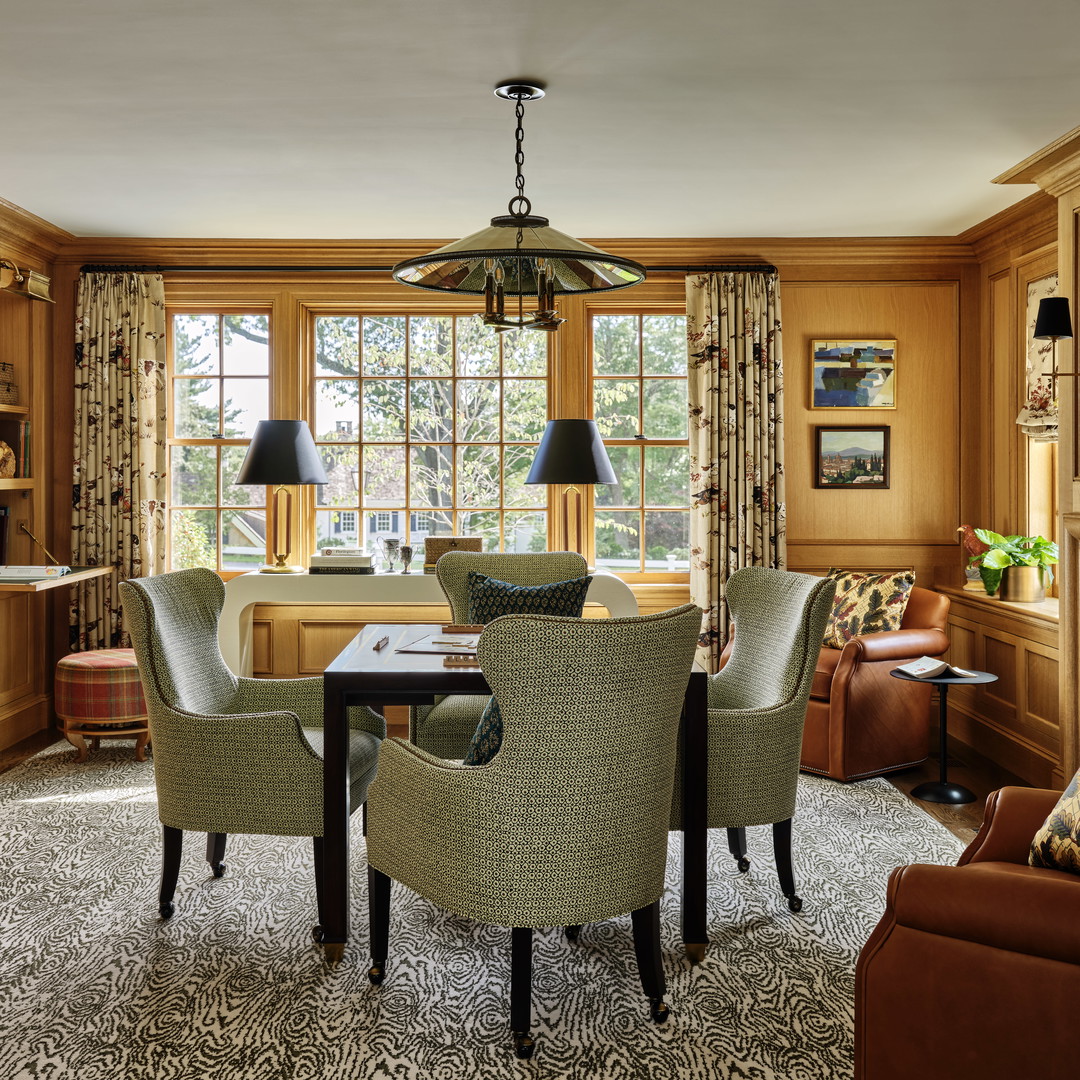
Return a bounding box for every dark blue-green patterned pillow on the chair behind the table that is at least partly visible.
[464,570,593,765]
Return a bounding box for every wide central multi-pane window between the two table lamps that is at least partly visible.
[311,314,548,559]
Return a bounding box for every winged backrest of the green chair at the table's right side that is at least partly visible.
[710,566,836,708]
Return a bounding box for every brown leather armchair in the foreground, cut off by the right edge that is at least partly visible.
[855,787,1080,1080]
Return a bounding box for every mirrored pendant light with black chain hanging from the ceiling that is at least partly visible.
[392,81,645,333]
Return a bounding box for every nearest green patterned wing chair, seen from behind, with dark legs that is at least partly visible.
[367,604,701,1057]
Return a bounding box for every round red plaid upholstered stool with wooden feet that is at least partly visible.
[55,649,150,761]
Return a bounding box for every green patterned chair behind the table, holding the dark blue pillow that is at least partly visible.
[409,551,588,760]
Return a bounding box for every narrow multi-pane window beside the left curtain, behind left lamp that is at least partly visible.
[168,313,270,570]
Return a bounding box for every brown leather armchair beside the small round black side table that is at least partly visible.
[799,586,949,780]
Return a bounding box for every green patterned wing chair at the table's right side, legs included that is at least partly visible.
[672,566,836,910]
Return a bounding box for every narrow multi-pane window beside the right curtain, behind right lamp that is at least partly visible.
[591,314,690,573]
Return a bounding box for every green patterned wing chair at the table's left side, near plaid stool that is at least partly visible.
[120,569,386,933]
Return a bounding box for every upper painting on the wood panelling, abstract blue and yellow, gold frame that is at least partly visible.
[810,338,896,409]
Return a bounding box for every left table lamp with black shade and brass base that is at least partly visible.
[233,420,326,573]
